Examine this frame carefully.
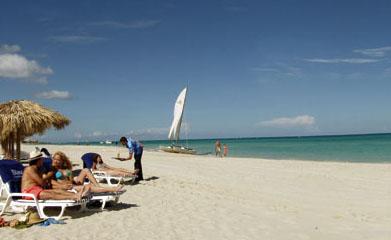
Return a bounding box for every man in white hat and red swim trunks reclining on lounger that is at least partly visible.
[22,151,89,201]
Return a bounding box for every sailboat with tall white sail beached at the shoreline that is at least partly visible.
[160,87,197,154]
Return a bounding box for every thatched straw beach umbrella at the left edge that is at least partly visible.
[0,100,70,159]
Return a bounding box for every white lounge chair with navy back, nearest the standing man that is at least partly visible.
[81,153,135,186]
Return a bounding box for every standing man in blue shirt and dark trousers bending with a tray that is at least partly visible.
[119,137,144,182]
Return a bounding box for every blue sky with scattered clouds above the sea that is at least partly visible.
[0,0,391,142]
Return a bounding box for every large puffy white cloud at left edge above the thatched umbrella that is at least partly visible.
[0,53,53,83]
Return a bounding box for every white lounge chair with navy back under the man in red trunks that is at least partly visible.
[0,160,89,220]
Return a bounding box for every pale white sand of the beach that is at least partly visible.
[0,145,391,240]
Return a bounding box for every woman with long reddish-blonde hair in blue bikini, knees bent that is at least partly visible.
[51,151,124,193]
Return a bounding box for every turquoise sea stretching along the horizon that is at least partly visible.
[64,133,391,163]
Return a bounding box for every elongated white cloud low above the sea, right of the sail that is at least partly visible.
[257,115,315,128]
